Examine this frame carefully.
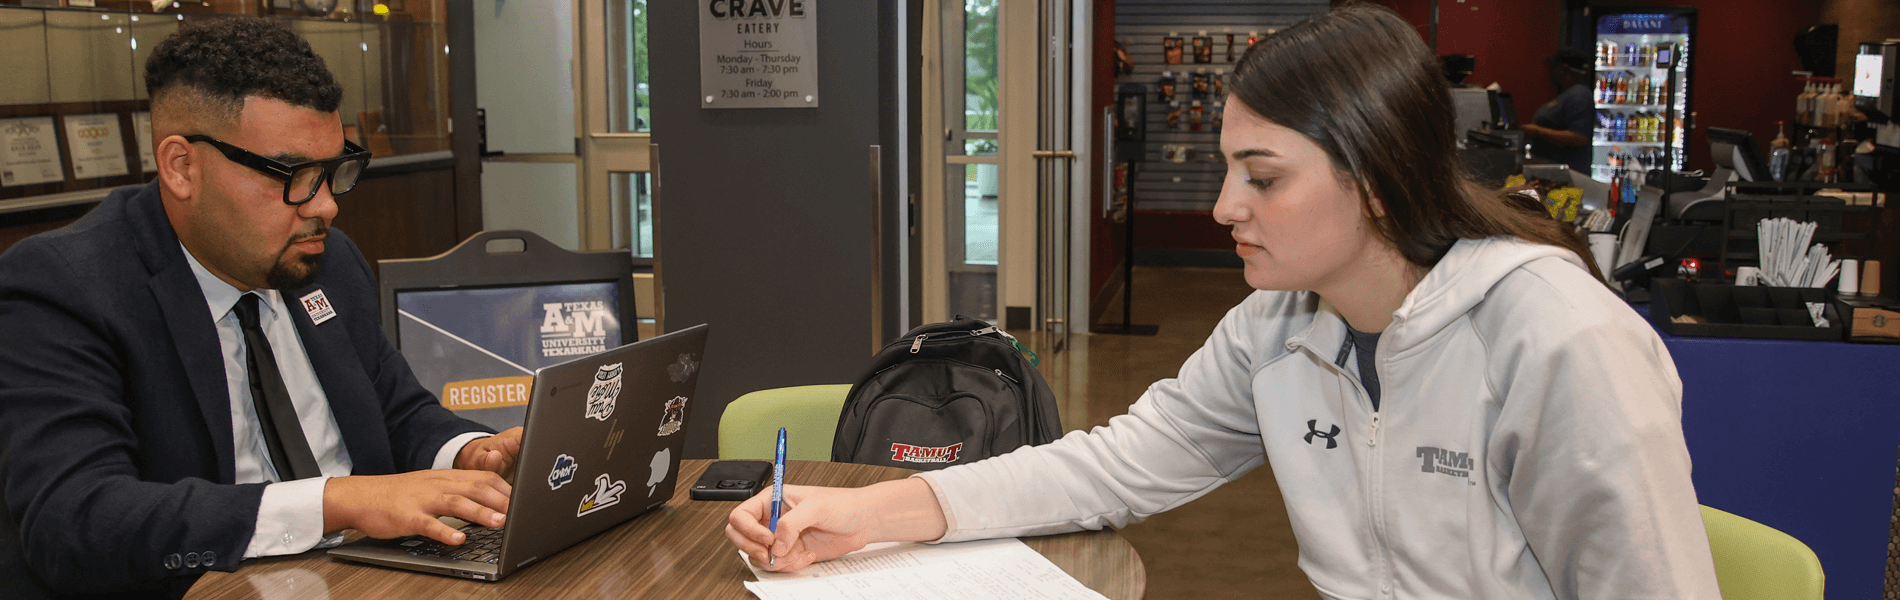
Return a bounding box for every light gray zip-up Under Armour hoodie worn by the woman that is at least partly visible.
[922,237,1720,600]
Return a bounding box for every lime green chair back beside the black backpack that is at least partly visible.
[718,384,851,461]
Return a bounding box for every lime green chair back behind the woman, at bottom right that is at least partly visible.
[1702,507,1826,600]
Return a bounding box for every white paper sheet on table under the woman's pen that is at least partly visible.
[739,537,1106,600]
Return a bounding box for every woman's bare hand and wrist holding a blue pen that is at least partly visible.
[726,478,946,572]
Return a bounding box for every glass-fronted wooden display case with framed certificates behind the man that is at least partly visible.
[0,0,452,207]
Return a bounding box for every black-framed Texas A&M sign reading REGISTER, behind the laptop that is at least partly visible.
[376,230,638,429]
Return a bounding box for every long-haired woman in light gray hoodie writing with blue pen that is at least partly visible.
[726,6,1720,598]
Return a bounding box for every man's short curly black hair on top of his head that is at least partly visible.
[144,17,344,118]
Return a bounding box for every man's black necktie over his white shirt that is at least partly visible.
[232,294,323,480]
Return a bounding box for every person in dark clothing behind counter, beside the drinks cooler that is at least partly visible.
[1522,51,1596,175]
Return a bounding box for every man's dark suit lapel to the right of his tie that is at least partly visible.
[283,285,395,475]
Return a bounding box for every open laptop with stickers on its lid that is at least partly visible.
[331,325,707,581]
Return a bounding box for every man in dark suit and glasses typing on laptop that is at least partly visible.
[0,19,521,598]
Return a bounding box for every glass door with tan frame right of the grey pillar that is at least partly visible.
[920,0,1091,349]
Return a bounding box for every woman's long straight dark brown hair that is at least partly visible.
[1227,4,1602,281]
